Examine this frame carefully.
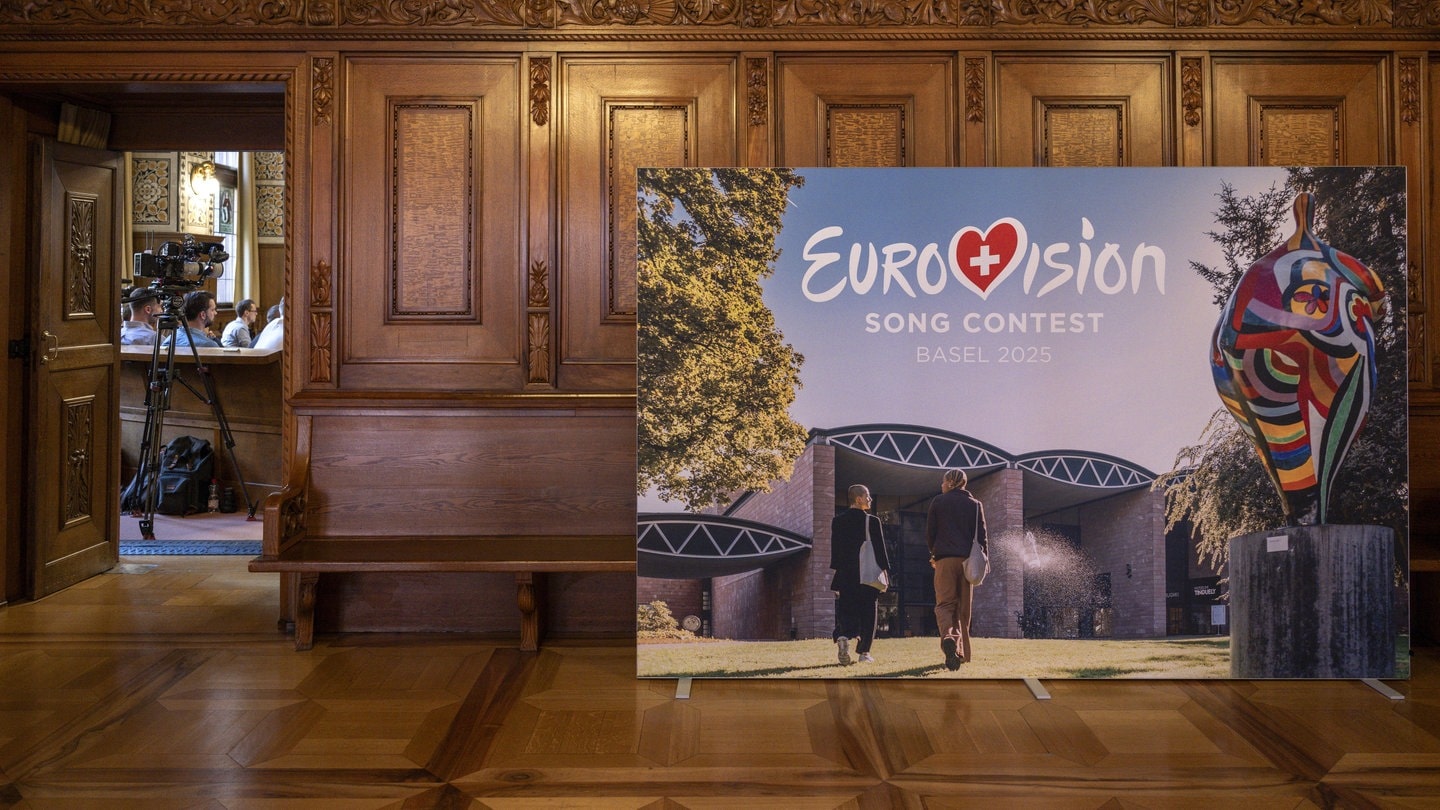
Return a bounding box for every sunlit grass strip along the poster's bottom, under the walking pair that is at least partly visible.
[636,637,1230,679]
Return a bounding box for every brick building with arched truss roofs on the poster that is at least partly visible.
[636,425,1223,638]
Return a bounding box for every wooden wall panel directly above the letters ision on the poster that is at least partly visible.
[995,55,1174,167]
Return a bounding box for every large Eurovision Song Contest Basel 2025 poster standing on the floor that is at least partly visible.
[635,167,1410,679]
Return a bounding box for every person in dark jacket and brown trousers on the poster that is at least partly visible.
[924,470,989,672]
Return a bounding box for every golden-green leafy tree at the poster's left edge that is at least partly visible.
[635,169,806,512]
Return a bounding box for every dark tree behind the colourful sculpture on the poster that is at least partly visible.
[1156,167,1408,568]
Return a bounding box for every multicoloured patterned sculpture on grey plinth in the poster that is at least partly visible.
[1210,195,1385,526]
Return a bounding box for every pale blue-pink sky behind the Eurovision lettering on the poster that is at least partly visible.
[641,169,1307,509]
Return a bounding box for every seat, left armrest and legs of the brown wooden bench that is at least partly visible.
[249,409,635,651]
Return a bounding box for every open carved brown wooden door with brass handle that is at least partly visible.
[26,140,124,598]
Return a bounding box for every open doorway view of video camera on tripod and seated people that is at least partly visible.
[120,150,285,547]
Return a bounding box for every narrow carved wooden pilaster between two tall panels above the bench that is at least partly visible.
[524,52,556,388]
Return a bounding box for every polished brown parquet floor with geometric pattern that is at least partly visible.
[0,558,1440,810]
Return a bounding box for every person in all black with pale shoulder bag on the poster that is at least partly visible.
[829,484,890,664]
